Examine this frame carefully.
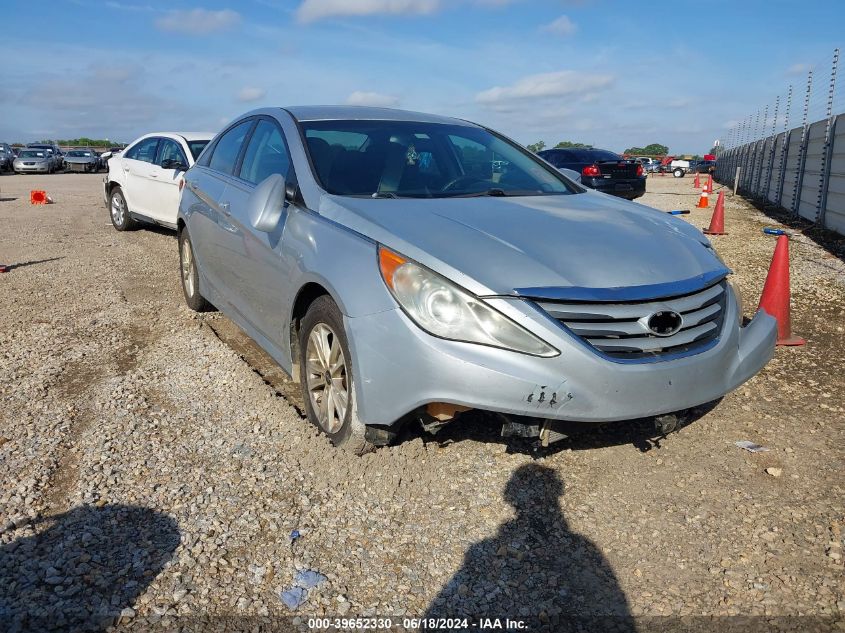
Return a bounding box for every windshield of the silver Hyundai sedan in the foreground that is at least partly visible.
[300,121,582,198]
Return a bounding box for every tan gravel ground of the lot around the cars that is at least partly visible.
[0,174,845,631]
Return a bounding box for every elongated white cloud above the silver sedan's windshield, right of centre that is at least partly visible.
[475,70,613,105]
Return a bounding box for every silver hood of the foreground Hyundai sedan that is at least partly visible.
[319,192,730,299]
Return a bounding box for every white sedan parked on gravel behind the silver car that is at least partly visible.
[103,132,214,231]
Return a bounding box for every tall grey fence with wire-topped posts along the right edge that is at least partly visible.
[716,49,845,235]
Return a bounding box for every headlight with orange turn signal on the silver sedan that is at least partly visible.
[379,246,560,358]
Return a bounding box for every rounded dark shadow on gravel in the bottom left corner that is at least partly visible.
[0,505,180,632]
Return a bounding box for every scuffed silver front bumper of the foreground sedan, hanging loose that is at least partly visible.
[346,293,777,425]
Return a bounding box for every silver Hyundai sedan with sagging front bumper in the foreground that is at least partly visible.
[177,106,776,452]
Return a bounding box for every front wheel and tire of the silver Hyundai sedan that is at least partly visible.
[299,295,375,455]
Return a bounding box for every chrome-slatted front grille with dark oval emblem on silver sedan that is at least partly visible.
[537,281,727,359]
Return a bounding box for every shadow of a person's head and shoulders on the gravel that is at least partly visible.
[424,463,636,633]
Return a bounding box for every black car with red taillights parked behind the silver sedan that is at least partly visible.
[537,149,646,200]
